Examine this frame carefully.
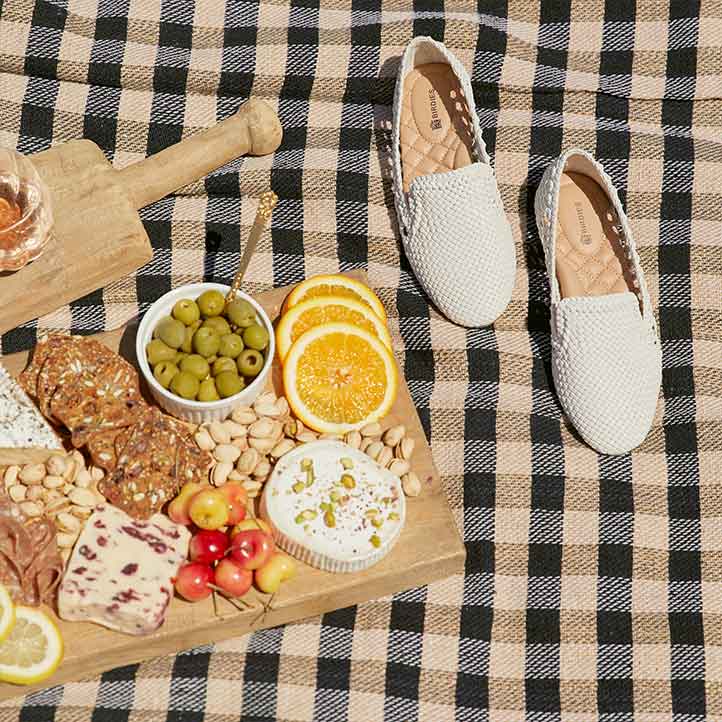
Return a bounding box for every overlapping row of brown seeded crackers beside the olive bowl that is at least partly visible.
[23,336,212,519]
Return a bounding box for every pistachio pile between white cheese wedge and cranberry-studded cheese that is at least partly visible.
[2,450,104,560]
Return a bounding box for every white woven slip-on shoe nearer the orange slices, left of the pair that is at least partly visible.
[392,37,516,327]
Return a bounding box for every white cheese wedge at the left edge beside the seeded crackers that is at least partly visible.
[0,366,63,449]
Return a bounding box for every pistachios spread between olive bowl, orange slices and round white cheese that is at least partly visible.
[195,392,421,498]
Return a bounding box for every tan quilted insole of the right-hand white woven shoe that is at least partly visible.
[556,172,634,298]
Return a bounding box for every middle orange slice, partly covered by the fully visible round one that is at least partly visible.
[276,296,391,361]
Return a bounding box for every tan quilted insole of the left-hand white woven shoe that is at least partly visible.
[399,63,473,193]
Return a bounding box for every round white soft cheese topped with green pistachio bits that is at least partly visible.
[261,441,406,572]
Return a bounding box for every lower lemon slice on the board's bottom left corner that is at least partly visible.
[0,606,63,684]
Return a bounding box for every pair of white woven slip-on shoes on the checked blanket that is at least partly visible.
[392,37,662,454]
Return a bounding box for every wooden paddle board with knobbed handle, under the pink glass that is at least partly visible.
[0,98,282,333]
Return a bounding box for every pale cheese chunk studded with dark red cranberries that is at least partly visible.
[58,505,190,634]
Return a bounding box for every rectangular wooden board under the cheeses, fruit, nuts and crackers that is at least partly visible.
[0,273,466,699]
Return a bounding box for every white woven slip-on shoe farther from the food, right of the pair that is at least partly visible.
[534,149,662,454]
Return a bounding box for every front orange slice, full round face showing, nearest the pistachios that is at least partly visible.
[283,323,398,434]
